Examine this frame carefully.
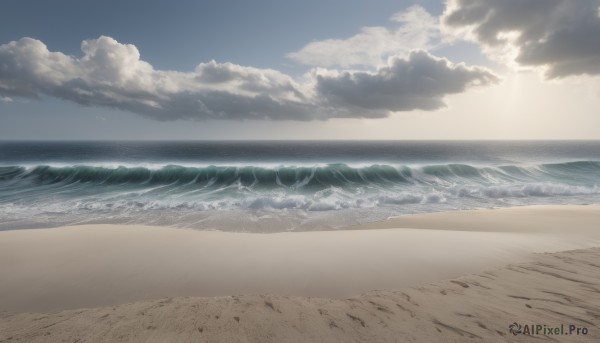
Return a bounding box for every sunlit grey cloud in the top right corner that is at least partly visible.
[442,0,600,78]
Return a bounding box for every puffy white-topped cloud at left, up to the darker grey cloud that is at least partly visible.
[0,36,312,120]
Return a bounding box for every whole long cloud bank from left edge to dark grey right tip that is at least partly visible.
[0,36,497,121]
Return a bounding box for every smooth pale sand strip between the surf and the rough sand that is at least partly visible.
[0,205,600,312]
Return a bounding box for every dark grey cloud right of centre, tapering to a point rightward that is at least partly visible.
[315,51,499,116]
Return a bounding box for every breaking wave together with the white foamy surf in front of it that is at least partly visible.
[0,161,600,231]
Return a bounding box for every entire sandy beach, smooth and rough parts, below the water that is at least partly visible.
[0,205,600,342]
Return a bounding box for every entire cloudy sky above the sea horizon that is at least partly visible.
[0,0,600,140]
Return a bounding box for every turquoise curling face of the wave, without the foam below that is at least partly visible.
[0,161,600,190]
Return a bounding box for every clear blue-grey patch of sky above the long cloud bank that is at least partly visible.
[0,0,443,70]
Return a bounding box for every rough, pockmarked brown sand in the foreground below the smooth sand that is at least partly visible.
[0,249,600,342]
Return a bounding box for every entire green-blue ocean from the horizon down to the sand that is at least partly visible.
[0,141,600,232]
